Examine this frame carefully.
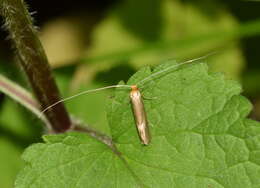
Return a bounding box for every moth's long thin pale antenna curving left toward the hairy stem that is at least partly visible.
[39,85,131,117]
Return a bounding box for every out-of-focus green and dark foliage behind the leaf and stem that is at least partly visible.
[0,0,260,188]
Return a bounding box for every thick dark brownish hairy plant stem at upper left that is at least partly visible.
[0,0,71,133]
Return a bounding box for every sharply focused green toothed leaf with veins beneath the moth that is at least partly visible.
[15,63,260,188]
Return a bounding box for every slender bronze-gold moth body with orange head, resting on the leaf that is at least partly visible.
[130,85,150,145]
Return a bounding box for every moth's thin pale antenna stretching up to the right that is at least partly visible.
[137,52,218,85]
